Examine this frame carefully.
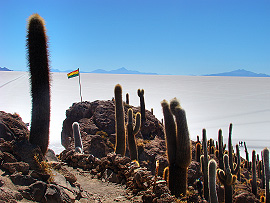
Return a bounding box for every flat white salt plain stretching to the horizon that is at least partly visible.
[0,71,270,159]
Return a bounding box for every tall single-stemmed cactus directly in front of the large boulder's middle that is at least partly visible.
[114,84,126,156]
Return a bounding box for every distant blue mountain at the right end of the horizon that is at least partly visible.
[204,69,270,77]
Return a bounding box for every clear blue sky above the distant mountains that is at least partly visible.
[0,0,270,75]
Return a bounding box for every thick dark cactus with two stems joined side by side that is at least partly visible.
[161,98,191,197]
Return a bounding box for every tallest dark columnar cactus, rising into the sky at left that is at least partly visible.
[27,14,50,155]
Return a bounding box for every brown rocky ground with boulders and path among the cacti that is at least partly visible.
[0,101,264,202]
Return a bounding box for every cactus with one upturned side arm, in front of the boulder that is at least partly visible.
[127,108,141,161]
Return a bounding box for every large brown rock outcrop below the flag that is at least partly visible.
[61,100,164,154]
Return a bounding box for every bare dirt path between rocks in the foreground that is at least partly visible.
[65,166,142,203]
